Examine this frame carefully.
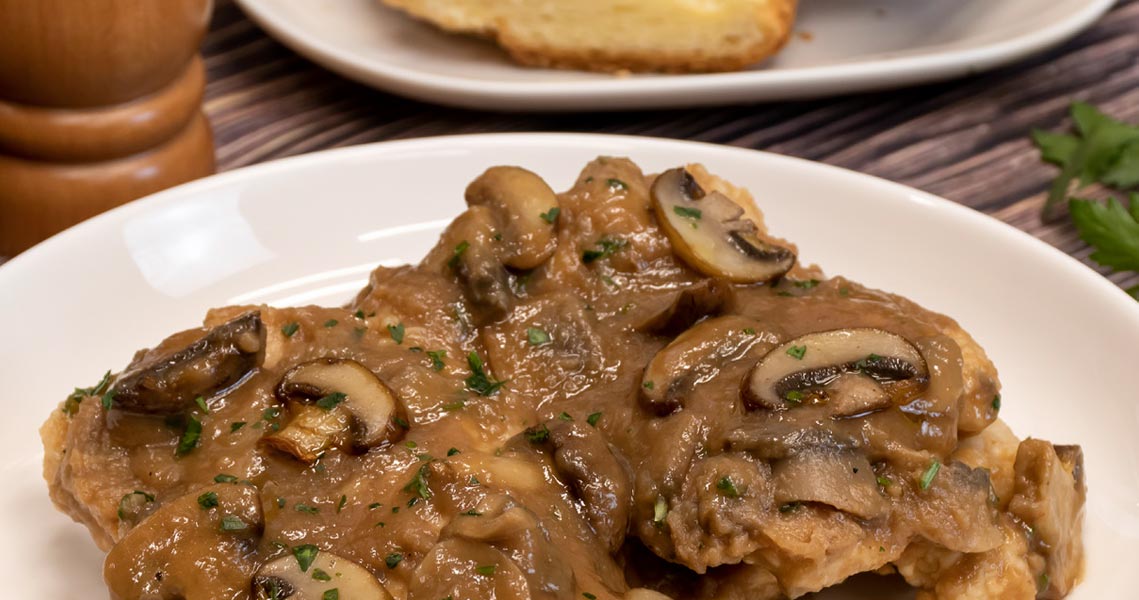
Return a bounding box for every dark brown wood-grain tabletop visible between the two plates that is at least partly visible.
[2,0,1139,296]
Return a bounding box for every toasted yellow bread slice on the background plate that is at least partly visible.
[383,0,797,72]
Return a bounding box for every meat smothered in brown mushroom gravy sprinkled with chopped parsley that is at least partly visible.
[41,158,1085,600]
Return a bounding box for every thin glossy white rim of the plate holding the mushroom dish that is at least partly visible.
[8,132,1139,316]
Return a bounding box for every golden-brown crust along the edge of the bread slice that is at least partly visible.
[383,0,798,73]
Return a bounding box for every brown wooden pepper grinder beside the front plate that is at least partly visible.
[0,0,214,256]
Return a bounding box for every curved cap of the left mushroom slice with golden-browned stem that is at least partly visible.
[277,357,408,449]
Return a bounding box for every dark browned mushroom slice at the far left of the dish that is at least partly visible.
[110,312,265,414]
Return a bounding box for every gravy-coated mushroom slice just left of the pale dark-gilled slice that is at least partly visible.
[640,315,775,416]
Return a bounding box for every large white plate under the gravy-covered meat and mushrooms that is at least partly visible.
[0,134,1139,600]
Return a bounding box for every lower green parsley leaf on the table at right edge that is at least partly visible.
[1068,194,1139,271]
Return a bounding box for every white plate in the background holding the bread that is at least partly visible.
[237,0,1114,110]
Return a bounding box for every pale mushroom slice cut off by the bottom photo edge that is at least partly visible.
[253,550,393,600]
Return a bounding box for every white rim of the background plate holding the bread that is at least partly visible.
[235,0,1116,112]
